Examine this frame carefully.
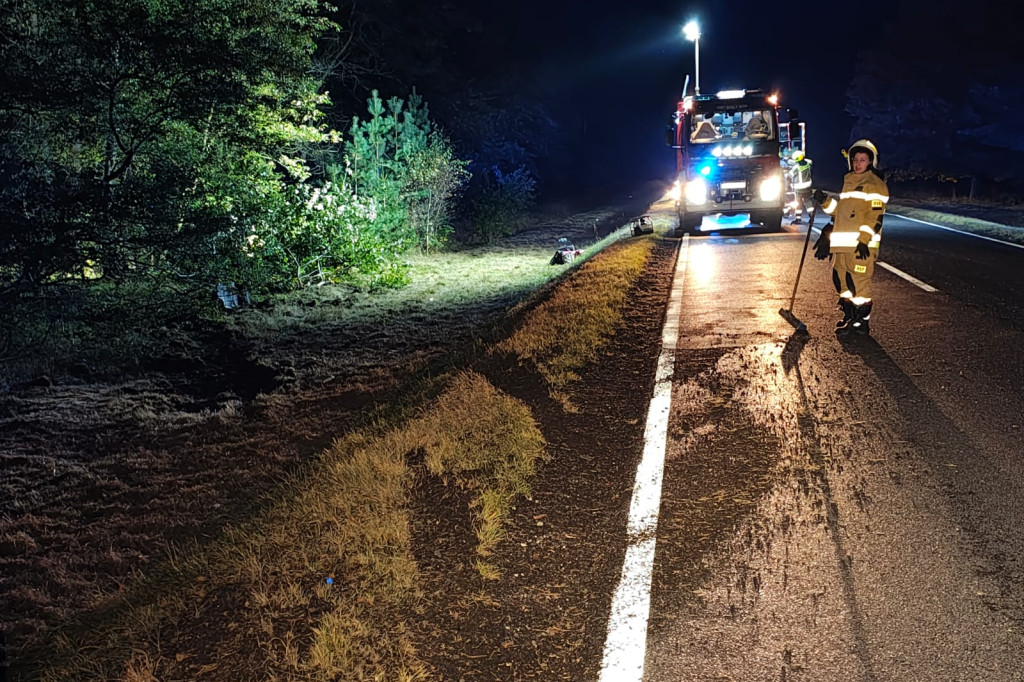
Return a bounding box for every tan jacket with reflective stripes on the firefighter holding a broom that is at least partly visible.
[821,170,889,253]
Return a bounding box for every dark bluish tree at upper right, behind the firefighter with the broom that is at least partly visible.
[848,0,1024,187]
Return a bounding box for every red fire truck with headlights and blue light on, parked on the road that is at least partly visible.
[666,90,804,233]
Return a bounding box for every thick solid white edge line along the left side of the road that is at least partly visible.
[600,235,690,682]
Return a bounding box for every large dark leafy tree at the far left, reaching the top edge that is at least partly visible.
[0,0,329,295]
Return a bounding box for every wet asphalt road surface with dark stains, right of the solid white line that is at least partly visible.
[630,205,1024,682]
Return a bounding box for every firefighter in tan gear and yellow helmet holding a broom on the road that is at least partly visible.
[813,139,889,334]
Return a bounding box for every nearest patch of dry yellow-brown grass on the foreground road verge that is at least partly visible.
[25,372,545,682]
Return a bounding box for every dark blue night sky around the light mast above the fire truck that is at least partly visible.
[444,0,892,184]
